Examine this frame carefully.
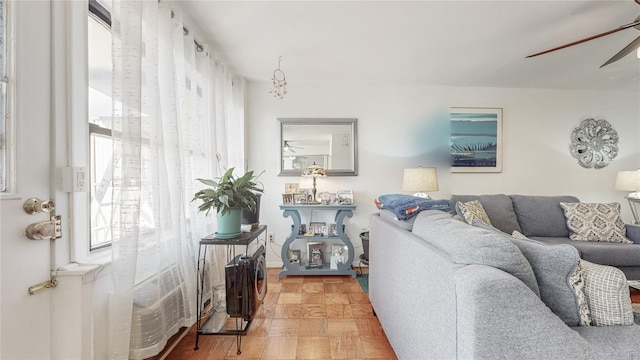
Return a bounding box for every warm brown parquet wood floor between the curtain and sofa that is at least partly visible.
[165,269,397,360]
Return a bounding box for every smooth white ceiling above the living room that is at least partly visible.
[179,0,640,91]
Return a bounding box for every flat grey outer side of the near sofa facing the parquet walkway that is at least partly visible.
[369,215,457,359]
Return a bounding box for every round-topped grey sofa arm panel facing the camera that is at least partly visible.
[455,265,593,359]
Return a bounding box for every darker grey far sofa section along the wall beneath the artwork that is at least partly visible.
[451,194,640,280]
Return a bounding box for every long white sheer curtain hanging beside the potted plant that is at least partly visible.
[108,0,244,359]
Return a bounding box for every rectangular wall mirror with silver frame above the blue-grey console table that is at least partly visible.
[278,118,358,176]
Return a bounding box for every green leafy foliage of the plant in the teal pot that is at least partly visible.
[191,168,264,215]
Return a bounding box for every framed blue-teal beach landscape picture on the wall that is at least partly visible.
[449,107,502,172]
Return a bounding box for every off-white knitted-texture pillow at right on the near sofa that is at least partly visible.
[581,260,633,326]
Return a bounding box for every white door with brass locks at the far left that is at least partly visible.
[0,0,55,360]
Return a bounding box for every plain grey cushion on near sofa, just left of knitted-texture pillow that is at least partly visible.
[511,231,591,326]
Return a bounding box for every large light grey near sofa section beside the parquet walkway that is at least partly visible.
[369,210,640,360]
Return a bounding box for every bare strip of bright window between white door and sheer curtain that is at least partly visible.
[87,0,113,250]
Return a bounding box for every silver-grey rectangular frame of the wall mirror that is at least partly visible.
[278,118,358,176]
